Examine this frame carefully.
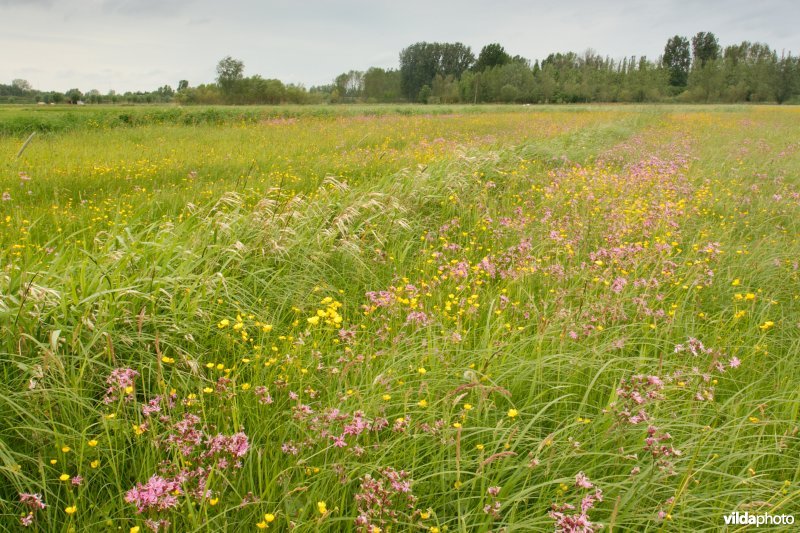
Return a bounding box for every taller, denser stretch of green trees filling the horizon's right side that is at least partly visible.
[320,32,800,103]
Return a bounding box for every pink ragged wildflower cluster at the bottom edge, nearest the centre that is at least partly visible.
[355,467,417,532]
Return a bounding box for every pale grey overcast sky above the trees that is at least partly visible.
[0,0,800,93]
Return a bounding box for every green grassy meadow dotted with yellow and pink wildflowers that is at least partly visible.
[0,106,800,533]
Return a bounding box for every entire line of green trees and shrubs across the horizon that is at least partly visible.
[6,32,800,105]
